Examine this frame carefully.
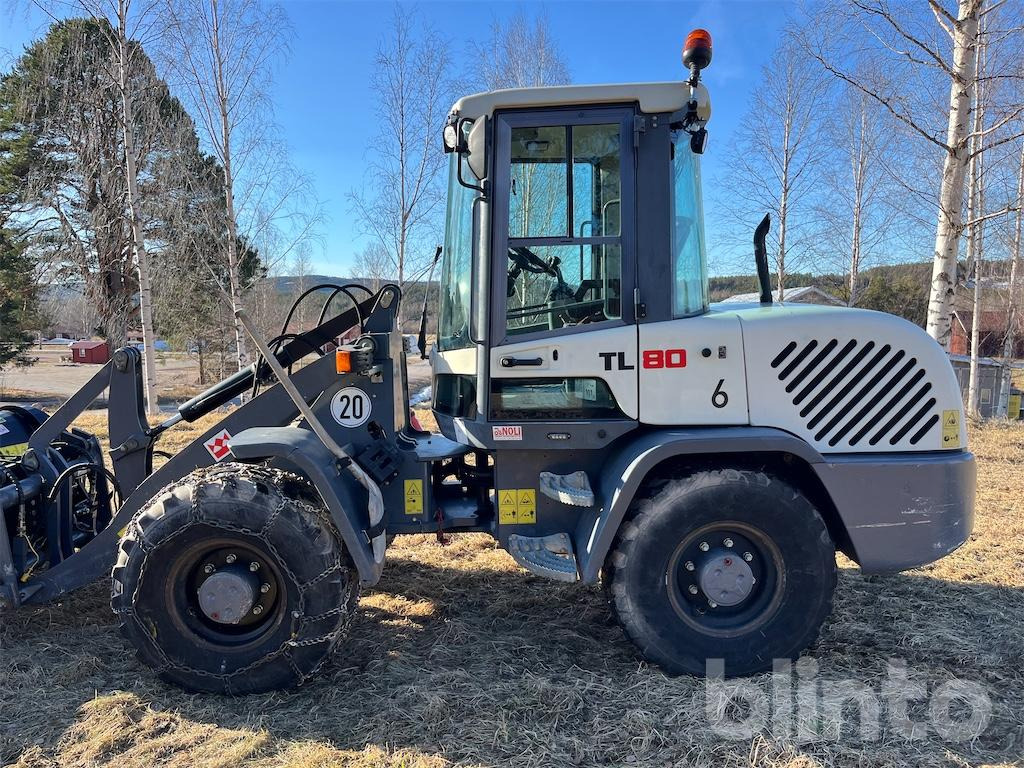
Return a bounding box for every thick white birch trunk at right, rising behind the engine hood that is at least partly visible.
[928,0,980,349]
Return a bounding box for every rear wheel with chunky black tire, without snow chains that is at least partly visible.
[603,469,836,677]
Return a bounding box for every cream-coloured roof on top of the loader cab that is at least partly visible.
[452,82,691,120]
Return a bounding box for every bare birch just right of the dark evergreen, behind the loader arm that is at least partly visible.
[164,0,321,369]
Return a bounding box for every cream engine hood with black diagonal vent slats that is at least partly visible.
[711,302,967,454]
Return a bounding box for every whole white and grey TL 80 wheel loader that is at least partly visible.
[0,31,975,694]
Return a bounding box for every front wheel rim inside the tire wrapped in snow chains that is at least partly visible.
[168,539,286,646]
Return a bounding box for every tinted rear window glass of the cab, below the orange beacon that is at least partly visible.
[672,131,708,317]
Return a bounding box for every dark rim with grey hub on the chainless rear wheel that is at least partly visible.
[666,521,785,637]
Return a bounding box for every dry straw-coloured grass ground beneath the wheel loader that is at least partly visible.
[0,417,1024,768]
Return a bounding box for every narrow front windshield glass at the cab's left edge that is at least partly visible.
[437,153,476,352]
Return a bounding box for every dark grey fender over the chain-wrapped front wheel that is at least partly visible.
[231,427,384,587]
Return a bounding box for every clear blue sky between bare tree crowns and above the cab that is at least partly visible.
[0,0,793,275]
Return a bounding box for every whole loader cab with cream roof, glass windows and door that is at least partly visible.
[431,83,710,449]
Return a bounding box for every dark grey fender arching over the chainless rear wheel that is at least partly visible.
[575,427,824,584]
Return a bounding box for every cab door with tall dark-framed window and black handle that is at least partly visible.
[487,108,639,423]
